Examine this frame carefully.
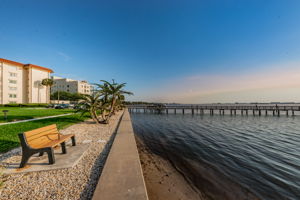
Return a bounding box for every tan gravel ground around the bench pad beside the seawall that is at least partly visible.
[0,112,122,199]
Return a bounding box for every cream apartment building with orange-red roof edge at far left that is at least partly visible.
[0,58,53,104]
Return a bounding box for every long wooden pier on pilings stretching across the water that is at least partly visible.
[128,104,300,116]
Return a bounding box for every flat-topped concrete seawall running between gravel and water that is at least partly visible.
[93,110,148,200]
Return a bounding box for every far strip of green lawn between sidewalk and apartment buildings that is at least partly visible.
[0,107,74,123]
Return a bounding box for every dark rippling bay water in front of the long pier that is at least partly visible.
[131,113,300,199]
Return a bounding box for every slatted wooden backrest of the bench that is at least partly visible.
[24,124,60,148]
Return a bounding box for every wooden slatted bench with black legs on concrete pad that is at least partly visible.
[19,124,76,168]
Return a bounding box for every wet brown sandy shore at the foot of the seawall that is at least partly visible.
[136,137,207,200]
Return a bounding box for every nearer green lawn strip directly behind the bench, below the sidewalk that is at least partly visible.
[0,113,89,153]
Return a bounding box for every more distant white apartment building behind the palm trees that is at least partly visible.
[51,76,94,94]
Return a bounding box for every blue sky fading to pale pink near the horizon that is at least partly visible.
[0,0,300,103]
